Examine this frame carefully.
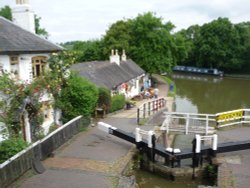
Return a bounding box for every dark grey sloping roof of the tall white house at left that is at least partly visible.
[0,16,62,54]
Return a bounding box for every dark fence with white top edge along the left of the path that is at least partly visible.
[0,116,90,187]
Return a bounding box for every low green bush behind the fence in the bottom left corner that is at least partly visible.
[0,138,28,164]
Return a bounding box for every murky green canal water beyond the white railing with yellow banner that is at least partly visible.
[172,74,250,113]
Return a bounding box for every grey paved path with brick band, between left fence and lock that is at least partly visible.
[17,79,170,188]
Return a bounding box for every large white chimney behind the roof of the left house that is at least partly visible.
[12,0,35,33]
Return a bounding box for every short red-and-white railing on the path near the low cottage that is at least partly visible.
[137,98,167,125]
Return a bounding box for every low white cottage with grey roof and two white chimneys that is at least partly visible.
[71,50,145,98]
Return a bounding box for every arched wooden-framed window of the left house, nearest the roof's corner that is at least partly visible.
[32,56,47,78]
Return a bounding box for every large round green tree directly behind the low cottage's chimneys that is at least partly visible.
[104,12,177,73]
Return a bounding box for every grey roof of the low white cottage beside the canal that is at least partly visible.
[71,60,145,89]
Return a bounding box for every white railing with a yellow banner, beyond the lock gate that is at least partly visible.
[161,109,250,135]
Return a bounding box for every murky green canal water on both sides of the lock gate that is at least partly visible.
[136,74,250,188]
